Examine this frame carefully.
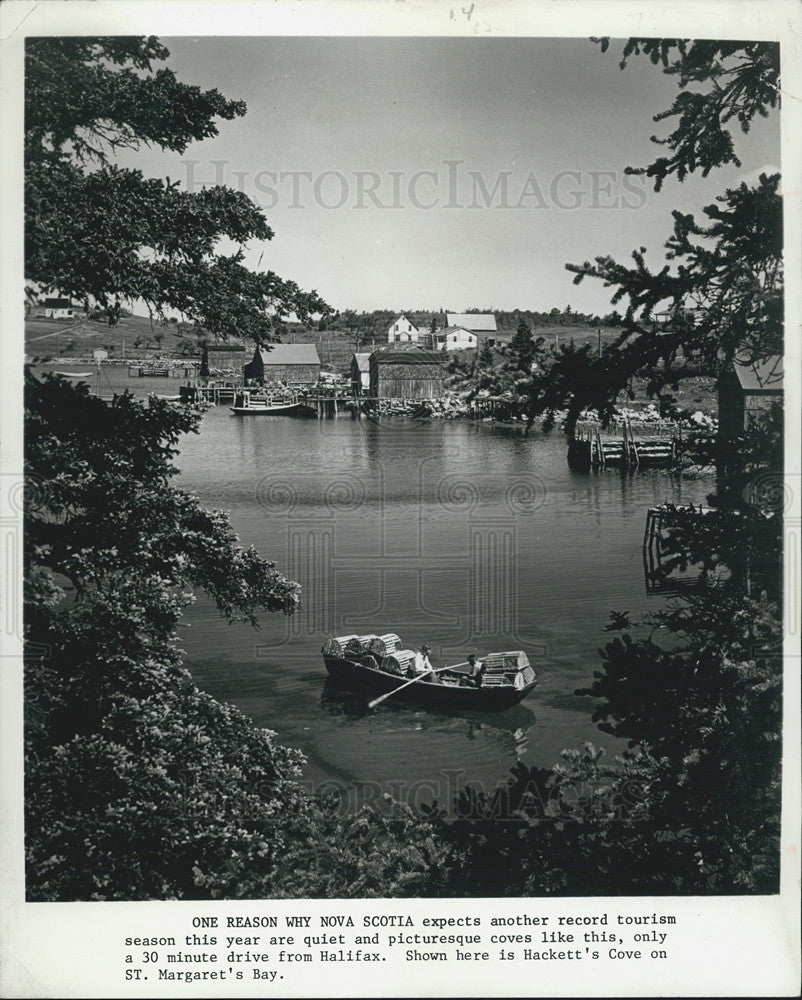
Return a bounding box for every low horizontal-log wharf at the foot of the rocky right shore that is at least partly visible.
[568,419,682,469]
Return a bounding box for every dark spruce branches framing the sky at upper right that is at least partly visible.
[528,38,783,424]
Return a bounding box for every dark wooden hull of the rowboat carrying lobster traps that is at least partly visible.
[323,653,537,712]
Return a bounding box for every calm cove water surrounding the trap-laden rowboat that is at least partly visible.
[39,366,712,801]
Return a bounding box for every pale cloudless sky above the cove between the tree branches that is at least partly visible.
[126,37,780,314]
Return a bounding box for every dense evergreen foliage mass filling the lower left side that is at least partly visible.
[25,377,302,899]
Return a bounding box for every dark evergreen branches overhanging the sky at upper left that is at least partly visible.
[25,37,327,342]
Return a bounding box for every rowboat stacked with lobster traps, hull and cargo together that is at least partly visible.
[322,636,537,711]
